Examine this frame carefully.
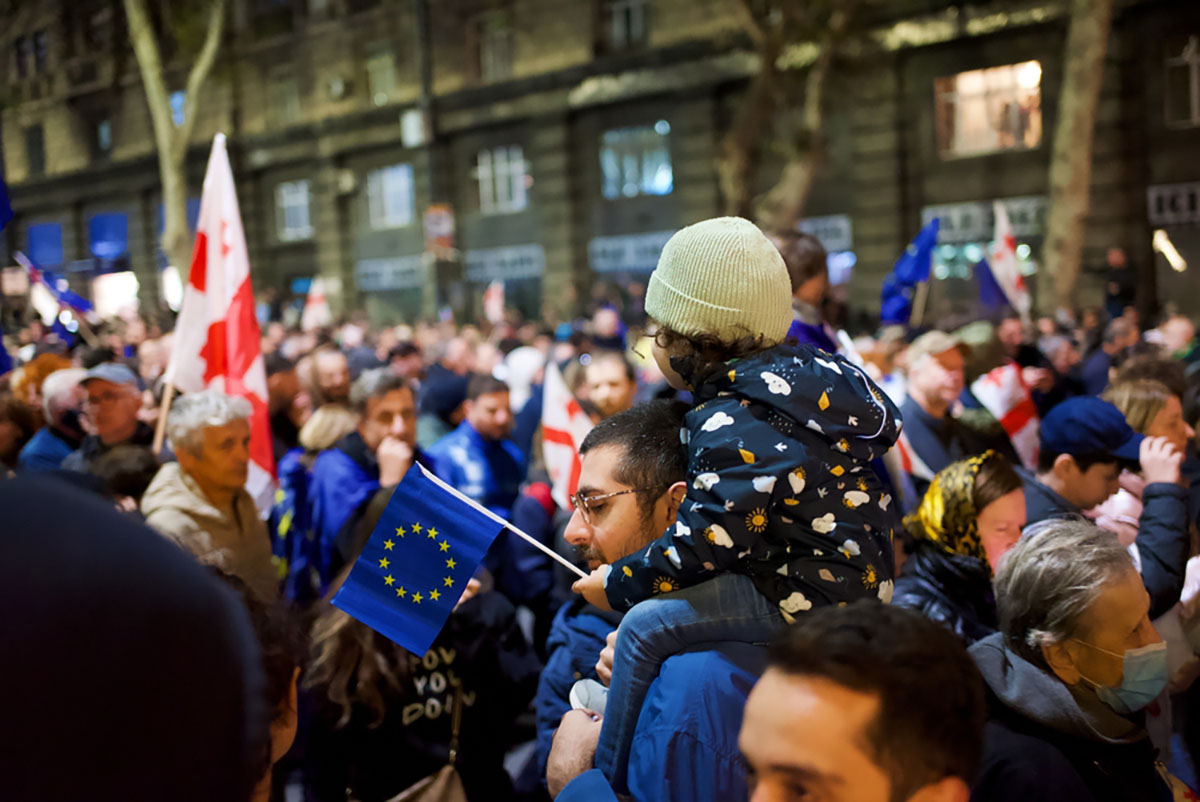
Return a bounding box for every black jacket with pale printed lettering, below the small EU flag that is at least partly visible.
[306,593,540,802]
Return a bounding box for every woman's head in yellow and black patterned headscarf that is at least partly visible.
[905,450,1025,571]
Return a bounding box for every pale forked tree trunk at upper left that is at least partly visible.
[125,0,228,289]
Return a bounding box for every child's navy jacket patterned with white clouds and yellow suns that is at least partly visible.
[605,343,900,618]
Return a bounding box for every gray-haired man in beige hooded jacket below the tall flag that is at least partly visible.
[142,390,278,599]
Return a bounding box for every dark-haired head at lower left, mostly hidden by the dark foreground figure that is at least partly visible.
[211,568,307,802]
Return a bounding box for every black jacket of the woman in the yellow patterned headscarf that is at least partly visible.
[892,543,996,646]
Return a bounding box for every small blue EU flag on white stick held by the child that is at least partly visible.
[334,462,503,654]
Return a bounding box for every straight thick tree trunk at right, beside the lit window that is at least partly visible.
[1038,0,1112,311]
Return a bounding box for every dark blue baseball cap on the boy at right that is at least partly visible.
[1040,395,1145,462]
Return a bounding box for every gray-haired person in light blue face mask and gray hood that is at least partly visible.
[971,519,1188,802]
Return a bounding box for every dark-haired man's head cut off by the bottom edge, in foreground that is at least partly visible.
[739,600,985,802]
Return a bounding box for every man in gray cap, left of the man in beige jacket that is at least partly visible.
[62,363,154,473]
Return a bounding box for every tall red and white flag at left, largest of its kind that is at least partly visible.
[166,133,275,510]
